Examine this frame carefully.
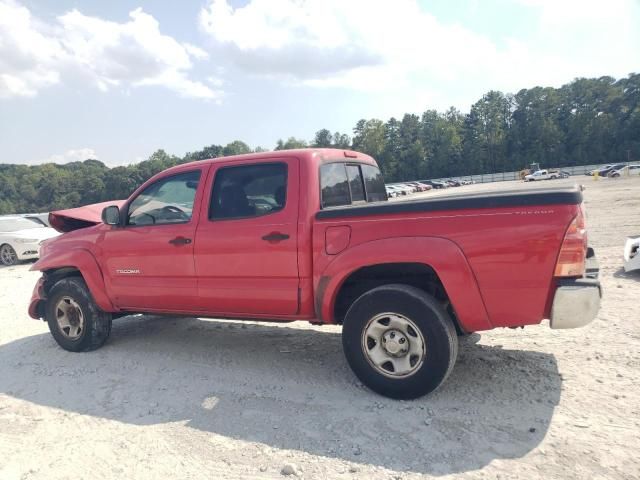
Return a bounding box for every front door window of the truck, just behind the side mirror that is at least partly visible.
[127,170,200,225]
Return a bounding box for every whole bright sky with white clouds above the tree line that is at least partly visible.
[0,0,640,166]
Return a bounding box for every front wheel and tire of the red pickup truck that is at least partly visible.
[45,277,111,352]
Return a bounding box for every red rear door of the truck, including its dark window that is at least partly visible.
[194,158,299,316]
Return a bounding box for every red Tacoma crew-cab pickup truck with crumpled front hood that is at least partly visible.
[29,149,601,398]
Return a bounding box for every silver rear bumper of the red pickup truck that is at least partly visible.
[550,248,602,329]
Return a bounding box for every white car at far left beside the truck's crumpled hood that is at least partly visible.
[0,216,60,265]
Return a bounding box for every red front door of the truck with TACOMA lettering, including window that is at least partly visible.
[100,167,208,312]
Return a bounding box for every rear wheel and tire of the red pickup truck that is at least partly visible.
[342,284,458,400]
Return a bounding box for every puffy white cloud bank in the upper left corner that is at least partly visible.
[0,0,222,100]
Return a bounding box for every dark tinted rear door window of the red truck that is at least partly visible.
[209,163,287,220]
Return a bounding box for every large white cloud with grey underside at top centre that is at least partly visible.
[200,0,496,84]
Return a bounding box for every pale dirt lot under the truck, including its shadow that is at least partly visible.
[0,177,640,479]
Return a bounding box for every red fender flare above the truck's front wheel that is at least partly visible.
[31,248,119,312]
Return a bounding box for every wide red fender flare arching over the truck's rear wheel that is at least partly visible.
[314,237,493,332]
